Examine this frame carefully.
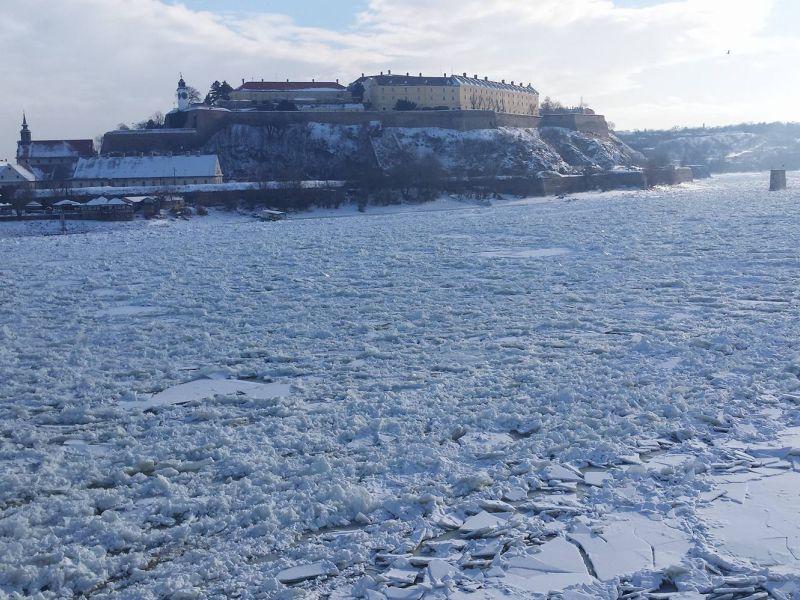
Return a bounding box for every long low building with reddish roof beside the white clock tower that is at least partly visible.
[231,79,352,106]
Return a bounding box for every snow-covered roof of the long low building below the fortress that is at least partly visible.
[74,154,222,179]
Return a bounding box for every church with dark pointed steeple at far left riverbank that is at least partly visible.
[17,114,96,182]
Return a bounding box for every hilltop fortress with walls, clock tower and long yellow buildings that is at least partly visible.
[100,71,608,155]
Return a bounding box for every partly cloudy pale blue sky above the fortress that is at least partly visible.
[0,0,800,159]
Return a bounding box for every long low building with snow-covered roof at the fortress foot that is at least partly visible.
[72,154,222,188]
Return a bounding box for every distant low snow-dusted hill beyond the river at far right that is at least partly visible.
[617,123,800,172]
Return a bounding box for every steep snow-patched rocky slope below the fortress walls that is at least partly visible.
[203,123,642,180]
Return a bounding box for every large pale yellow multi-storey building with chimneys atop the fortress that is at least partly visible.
[354,71,539,115]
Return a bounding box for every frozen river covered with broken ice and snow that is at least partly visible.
[0,175,800,600]
